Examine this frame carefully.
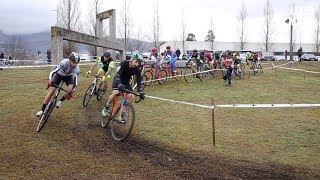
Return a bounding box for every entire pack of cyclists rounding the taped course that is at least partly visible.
[36,46,259,116]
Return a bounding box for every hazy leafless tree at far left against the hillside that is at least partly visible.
[3,35,27,60]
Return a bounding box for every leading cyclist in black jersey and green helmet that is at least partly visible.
[102,52,144,117]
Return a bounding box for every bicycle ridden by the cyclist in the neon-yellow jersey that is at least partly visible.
[82,75,106,106]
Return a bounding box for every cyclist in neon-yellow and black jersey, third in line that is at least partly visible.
[86,51,115,91]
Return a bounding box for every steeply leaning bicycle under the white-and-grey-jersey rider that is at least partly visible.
[37,81,68,132]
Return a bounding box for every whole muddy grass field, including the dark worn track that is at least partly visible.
[0,62,320,179]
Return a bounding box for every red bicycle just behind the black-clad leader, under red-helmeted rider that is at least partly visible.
[143,65,167,86]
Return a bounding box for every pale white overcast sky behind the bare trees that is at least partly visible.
[0,0,320,43]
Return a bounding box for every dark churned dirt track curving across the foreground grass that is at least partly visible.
[70,109,320,179]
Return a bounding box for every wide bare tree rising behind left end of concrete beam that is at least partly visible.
[58,0,81,57]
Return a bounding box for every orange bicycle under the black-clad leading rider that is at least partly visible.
[101,89,141,141]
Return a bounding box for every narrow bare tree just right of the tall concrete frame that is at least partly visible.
[119,0,132,50]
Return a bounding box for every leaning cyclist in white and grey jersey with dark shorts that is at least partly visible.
[36,52,80,117]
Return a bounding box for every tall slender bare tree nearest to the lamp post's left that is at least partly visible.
[263,0,274,51]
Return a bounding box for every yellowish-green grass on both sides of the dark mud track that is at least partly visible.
[0,62,320,178]
